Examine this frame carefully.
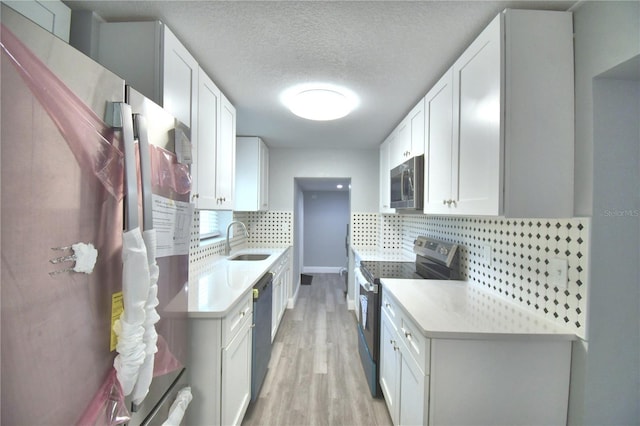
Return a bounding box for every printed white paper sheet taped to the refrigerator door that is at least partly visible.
[153,194,193,257]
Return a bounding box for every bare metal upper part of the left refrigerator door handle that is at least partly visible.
[105,102,140,231]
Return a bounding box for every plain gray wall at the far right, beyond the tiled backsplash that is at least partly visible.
[569,2,640,425]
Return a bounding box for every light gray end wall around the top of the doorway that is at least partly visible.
[269,148,379,213]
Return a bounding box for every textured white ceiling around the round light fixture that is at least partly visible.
[65,1,575,149]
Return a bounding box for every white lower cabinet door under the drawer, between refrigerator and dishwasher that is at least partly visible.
[222,320,252,425]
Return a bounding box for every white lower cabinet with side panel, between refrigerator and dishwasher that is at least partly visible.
[187,291,253,425]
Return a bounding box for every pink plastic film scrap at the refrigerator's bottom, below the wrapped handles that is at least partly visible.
[78,369,131,426]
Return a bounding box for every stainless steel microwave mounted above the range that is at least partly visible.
[391,155,424,210]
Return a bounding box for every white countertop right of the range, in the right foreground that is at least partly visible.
[382,278,576,340]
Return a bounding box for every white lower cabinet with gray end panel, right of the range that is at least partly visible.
[380,289,571,425]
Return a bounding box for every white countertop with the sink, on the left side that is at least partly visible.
[167,248,287,318]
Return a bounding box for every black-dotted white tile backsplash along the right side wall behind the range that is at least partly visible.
[400,215,590,338]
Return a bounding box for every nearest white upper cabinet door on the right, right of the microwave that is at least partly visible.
[452,16,503,215]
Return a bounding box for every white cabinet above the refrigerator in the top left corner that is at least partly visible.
[2,0,71,43]
